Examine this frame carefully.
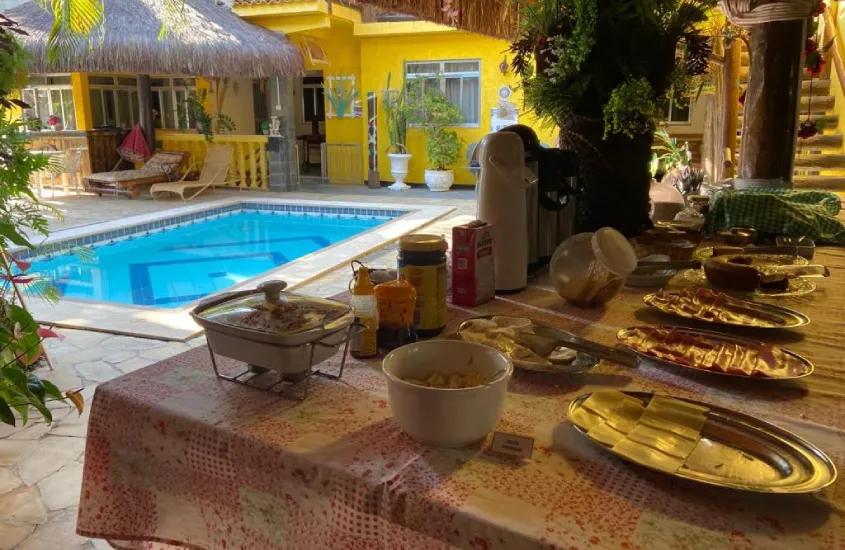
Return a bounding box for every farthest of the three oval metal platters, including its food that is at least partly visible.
[643,289,810,329]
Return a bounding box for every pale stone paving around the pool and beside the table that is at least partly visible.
[0,186,475,550]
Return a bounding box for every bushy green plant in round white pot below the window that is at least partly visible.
[414,85,464,191]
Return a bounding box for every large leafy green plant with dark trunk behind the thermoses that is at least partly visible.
[511,0,716,237]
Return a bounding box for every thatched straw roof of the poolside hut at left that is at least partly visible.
[4,0,305,78]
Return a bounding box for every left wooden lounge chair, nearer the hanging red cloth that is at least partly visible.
[85,151,188,198]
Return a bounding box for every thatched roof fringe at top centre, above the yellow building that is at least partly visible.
[234,0,518,39]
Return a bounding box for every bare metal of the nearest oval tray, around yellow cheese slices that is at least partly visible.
[569,392,836,493]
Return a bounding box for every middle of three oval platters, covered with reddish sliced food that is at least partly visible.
[618,326,810,378]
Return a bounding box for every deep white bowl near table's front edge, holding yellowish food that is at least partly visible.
[382,340,513,447]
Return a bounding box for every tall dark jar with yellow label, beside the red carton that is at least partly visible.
[396,234,448,338]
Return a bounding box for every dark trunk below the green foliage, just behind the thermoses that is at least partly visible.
[560,116,654,238]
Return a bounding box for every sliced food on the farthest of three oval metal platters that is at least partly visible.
[645,288,786,328]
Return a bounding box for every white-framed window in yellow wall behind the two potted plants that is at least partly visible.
[405,60,481,126]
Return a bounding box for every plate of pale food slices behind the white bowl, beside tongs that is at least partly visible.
[454,316,578,366]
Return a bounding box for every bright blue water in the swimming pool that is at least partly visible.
[31,211,387,308]
